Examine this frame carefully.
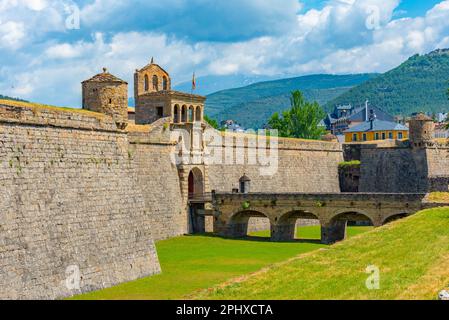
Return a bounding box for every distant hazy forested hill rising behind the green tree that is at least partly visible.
[206,74,377,128]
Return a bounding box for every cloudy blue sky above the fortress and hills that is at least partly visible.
[0,0,449,106]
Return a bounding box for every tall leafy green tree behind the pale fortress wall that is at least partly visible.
[268,91,325,140]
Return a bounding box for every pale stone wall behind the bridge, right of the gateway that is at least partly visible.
[208,135,343,192]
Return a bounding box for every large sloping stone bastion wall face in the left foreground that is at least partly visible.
[0,105,160,299]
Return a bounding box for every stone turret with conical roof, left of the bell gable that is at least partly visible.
[82,68,128,130]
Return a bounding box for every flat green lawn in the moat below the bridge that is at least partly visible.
[74,227,367,300]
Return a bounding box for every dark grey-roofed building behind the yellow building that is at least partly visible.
[324,101,395,136]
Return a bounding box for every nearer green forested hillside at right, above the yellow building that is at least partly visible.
[325,49,449,115]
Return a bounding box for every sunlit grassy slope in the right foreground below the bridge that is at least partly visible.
[195,208,449,299]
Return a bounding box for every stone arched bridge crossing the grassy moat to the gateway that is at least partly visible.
[212,193,437,244]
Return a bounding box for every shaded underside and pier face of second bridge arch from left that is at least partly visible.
[271,210,321,241]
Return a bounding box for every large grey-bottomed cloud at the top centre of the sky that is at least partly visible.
[81,0,301,41]
